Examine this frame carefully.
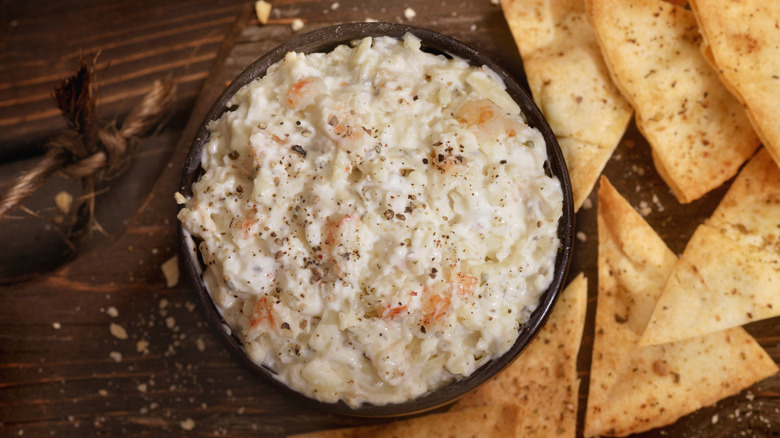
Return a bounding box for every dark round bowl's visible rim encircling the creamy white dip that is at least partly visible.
[179,23,574,417]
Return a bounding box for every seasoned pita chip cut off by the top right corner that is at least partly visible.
[691,0,780,163]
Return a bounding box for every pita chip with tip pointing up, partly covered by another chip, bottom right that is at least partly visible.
[584,177,778,436]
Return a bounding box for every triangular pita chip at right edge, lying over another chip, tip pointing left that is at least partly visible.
[642,149,780,345]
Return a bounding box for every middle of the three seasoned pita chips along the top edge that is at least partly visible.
[586,0,760,203]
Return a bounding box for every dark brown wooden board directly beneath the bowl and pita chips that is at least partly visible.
[0,0,780,437]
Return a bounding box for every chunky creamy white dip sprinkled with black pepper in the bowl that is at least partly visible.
[179,34,563,406]
